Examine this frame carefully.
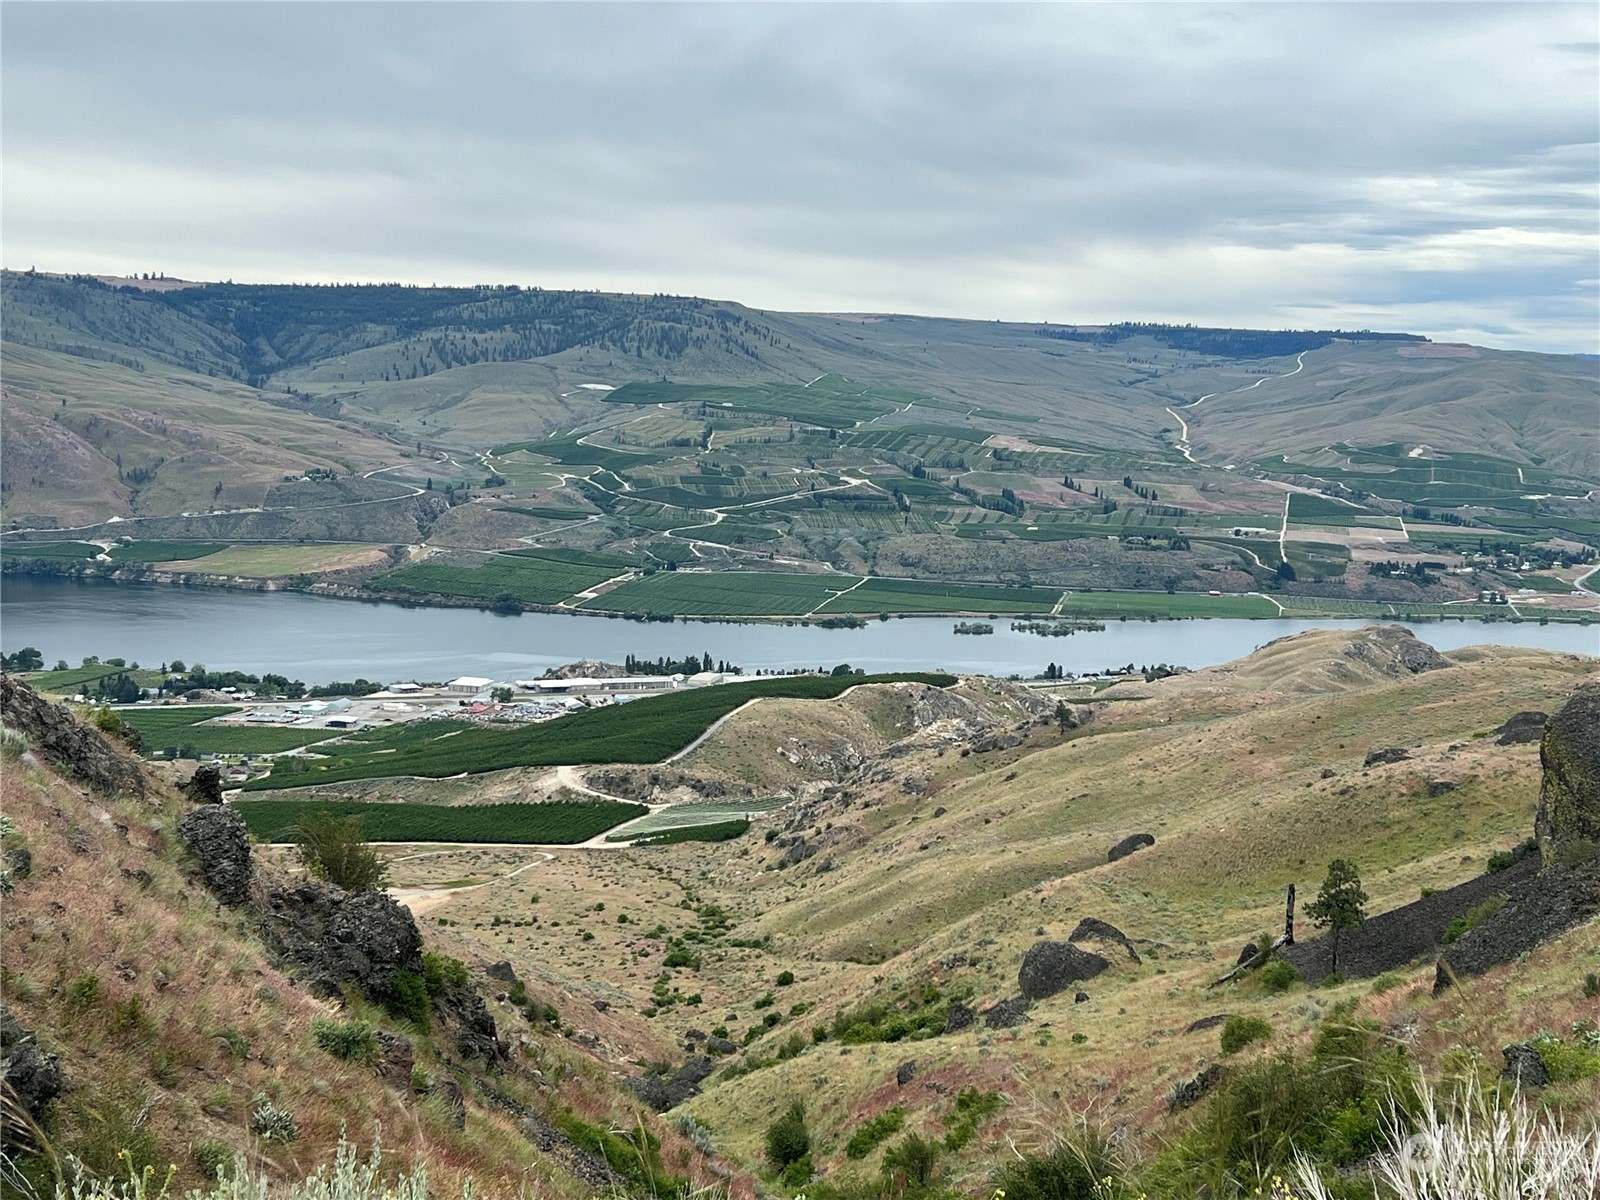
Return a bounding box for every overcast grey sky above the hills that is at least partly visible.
[0,0,1600,352]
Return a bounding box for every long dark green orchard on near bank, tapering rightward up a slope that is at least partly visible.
[245,672,955,790]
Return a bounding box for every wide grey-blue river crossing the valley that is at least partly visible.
[0,576,1600,683]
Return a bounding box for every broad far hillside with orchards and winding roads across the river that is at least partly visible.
[0,272,1600,630]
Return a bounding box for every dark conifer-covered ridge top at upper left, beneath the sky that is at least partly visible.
[5,272,770,386]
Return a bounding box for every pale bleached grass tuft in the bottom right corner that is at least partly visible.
[1294,1074,1600,1200]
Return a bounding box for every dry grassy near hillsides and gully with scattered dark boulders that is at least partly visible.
[3,626,1600,1198]
